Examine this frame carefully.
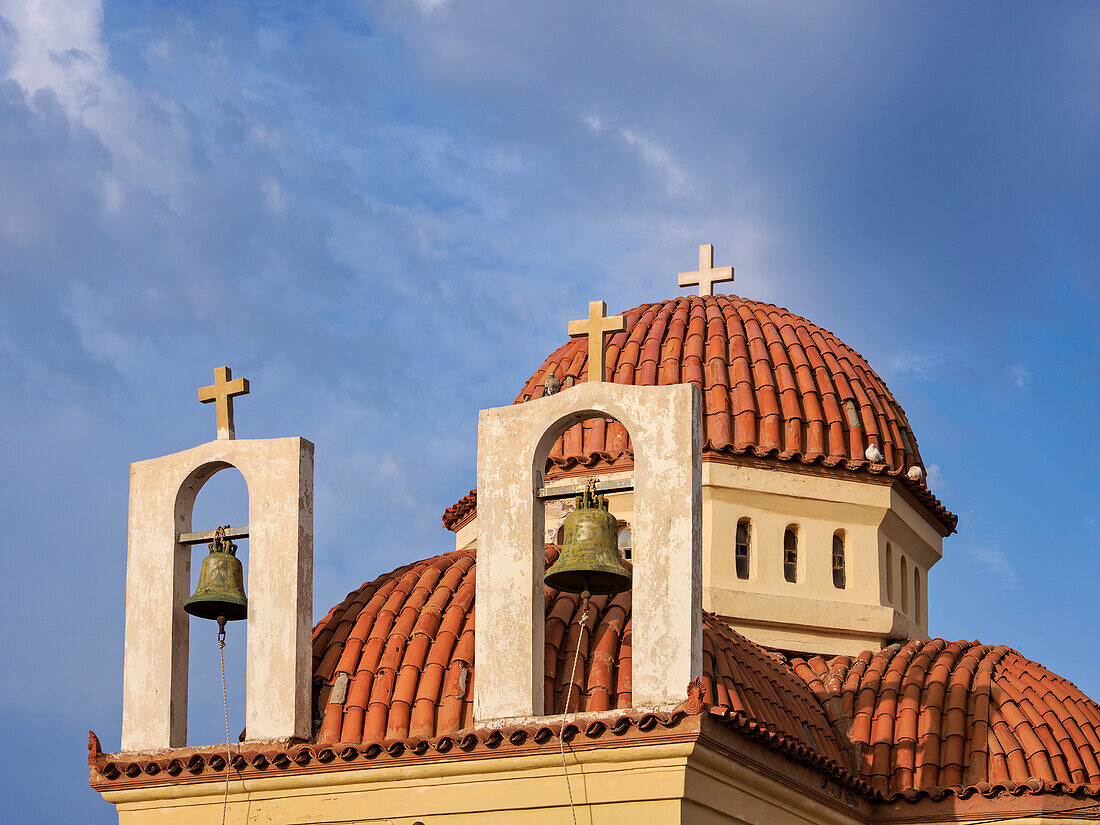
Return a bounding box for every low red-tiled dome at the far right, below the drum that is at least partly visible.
[792,639,1100,796]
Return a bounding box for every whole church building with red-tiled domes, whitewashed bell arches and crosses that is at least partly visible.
[89,246,1100,825]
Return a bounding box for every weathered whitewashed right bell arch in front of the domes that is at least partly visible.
[474,382,702,724]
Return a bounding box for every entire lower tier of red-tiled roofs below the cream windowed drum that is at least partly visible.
[312,547,1100,799]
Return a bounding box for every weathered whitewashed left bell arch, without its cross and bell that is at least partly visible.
[122,438,314,751]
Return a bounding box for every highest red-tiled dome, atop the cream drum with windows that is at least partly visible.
[443,295,957,532]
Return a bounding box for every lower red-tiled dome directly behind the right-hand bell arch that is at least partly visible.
[312,547,844,766]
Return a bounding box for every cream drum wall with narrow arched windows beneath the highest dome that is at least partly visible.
[455,460,943,656]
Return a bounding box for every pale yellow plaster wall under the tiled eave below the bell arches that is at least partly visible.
[103,743,875,825]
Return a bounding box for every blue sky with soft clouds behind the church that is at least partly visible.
[0,0,1100,823]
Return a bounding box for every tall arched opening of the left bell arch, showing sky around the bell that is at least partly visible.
[187,466,249,745]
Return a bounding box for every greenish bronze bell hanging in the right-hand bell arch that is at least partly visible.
[546,481,630,595]
